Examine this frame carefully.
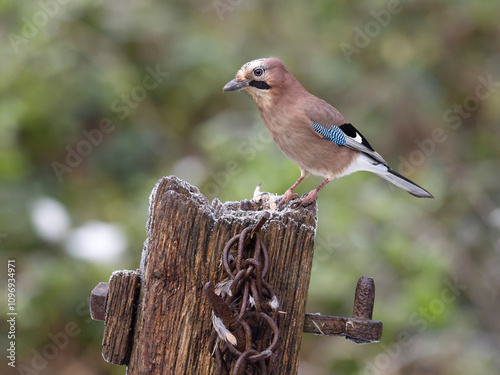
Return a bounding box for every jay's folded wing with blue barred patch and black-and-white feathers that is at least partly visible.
[306,98,387,165]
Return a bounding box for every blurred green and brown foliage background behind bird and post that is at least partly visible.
[0,0,500,375]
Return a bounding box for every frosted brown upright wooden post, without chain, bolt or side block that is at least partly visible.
[127,176,317,375]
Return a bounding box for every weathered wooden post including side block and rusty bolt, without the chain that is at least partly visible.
[91,176,382,375]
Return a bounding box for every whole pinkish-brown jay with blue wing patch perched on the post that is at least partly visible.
[223,57,434,206]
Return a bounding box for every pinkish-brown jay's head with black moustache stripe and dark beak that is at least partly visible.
[222,57,295,105]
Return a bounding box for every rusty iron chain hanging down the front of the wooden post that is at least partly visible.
[204,211,279,375]
